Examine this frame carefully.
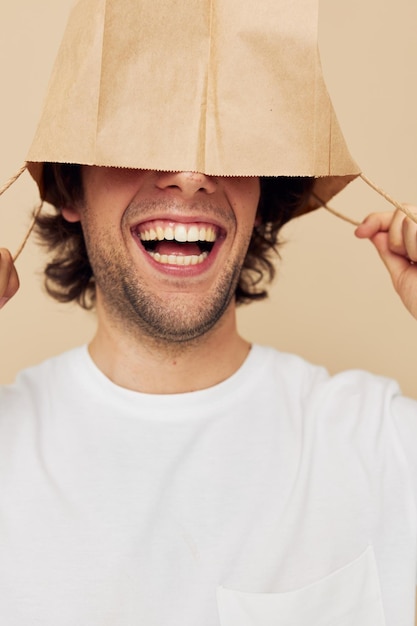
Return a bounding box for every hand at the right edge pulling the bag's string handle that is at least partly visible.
[355,205,417,319]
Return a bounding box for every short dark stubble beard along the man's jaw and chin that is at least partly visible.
[84,196,250,348]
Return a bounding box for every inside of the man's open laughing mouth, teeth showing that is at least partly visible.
[134,220,221,266]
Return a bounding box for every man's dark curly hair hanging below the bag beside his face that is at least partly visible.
[35,163,314,309]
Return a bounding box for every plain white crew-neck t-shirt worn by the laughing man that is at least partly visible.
[0,346,417,626]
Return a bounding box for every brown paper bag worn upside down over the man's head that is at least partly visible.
[27,0,359,209]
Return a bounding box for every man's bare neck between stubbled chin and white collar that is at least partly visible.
[89,303,250,394]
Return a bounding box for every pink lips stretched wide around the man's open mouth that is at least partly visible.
[130,215,227,278]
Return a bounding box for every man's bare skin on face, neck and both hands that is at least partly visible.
[0,167,417,393]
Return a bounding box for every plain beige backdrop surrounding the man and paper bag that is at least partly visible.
[0,0,417,397]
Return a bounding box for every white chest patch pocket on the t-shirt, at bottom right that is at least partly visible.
[217,547,385,626]
